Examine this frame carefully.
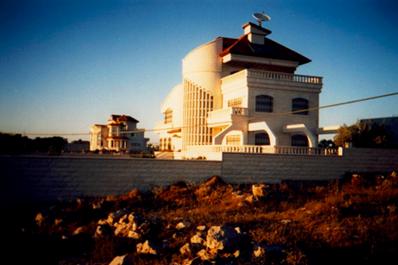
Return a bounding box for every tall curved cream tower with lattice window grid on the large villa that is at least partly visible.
[182,39,222,150]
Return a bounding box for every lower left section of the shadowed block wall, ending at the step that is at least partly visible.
[0,156,221,204]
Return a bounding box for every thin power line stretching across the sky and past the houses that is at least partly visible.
[6,92,398,136]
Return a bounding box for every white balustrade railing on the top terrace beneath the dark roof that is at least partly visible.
[247,70,322,85]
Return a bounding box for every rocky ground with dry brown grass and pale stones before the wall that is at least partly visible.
[1,172,398,265]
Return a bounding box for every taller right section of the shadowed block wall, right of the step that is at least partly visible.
[222,148,398,183]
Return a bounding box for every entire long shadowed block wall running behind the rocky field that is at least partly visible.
[0,149,398,205]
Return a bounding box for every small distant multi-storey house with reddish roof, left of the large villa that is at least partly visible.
[90,115,148,153]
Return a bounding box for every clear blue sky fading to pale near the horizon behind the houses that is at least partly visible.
[0,0,398,142]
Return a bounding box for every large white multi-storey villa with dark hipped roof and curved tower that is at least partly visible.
[156,22,334,160]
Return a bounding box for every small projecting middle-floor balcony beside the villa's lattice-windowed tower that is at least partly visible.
[207,107,248,127]
